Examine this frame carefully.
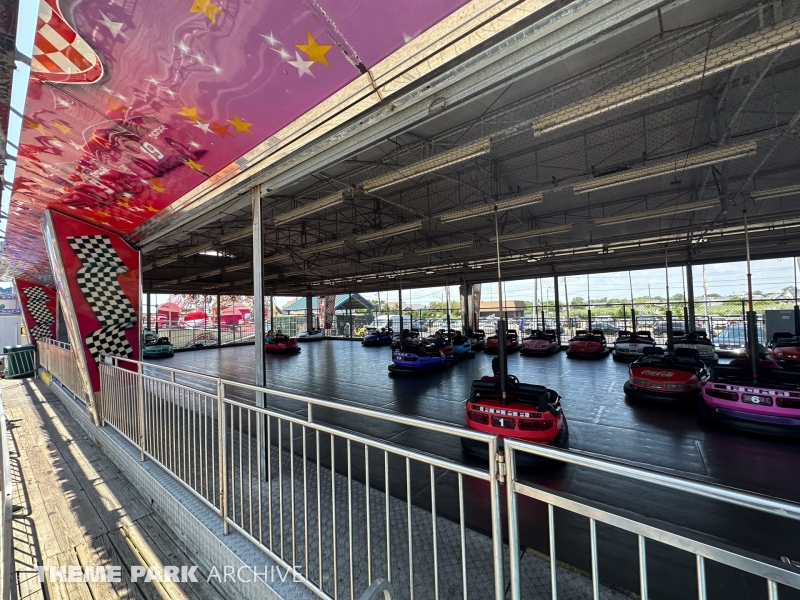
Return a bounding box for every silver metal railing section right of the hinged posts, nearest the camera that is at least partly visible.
[504,438,800,600]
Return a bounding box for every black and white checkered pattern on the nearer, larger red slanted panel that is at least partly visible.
[67,235,136,361]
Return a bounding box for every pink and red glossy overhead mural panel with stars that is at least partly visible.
[3,0,466,282]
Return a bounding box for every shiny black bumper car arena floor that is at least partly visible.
[152,341,800,600]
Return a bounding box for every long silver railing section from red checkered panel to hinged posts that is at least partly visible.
[100,357,504,598]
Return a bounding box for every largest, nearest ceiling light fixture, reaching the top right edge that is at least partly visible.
[533,21,800,135]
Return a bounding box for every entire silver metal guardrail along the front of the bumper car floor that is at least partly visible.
[53,357,800,600]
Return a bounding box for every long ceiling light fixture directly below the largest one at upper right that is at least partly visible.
[572,142,757,194]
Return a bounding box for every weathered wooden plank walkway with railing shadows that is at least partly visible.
[0,380,225,600]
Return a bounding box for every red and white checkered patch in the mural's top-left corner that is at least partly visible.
[31,0,103,83]
